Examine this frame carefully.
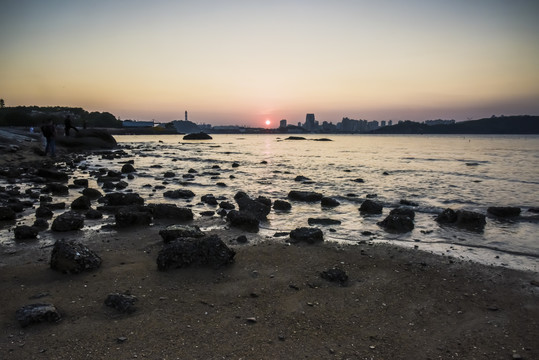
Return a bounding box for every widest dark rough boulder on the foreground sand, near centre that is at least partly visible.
[157,235,236,271]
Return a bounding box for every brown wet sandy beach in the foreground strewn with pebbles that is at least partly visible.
[0,130,539,359]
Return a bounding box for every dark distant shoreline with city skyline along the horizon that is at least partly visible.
[0,106,539,134]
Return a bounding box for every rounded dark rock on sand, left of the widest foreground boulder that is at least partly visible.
[51,240,101,274]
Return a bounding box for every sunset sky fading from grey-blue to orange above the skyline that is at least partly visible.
[0,0,539,126]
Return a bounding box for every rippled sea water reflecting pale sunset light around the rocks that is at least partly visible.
[1,135,539,271]
